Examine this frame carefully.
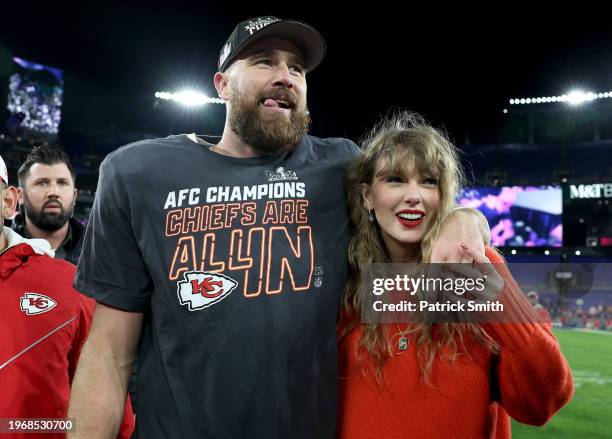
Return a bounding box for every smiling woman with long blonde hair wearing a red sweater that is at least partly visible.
[338,113,573,439]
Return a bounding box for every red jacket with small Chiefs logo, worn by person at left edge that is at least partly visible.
[0,232,134,439]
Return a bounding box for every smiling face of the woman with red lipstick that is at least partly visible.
[363,158,440,259]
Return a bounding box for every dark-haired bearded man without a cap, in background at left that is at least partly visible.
[12,145,84,265]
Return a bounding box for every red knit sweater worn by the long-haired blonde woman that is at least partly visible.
[338,249,574,439]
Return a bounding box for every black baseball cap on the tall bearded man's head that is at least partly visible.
[219,16,325,72]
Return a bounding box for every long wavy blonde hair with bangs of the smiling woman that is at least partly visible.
[341,112,497,382]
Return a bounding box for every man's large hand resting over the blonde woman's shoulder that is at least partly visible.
[431,208,491,263]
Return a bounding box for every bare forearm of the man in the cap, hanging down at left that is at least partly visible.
[68,303,143,439]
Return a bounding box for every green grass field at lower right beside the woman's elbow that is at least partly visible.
[512,330,612,439]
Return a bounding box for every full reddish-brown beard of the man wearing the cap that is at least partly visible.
[229,89,310,153]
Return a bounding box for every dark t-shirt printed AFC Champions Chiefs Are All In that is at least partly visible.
[75,135,358,439]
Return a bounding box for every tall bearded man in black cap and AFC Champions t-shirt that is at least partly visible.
[69,17,488,439]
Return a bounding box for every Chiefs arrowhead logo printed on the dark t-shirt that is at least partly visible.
[177,271,238,311]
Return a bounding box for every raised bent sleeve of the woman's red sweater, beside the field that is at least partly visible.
[482,249,574,425]
